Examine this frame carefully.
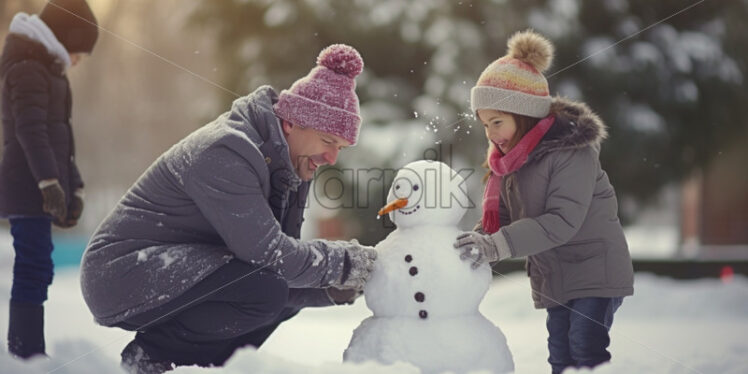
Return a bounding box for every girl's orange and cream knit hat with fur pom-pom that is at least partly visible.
[470,30,553,118]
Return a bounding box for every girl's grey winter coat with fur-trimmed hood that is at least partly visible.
[490,98,634,308]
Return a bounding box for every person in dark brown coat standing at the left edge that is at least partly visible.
[0,0,99,359]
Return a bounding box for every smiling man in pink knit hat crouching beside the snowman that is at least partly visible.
[81,45,376,373]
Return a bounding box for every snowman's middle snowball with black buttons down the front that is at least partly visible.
[364,226,491,319]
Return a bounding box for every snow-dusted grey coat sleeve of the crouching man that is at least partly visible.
[185,145,345,288]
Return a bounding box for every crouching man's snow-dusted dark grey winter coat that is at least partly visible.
[81,86,345,325]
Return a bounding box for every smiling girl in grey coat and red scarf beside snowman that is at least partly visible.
[455,31,634,373]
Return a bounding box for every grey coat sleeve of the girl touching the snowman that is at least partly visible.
[501,147,597,257]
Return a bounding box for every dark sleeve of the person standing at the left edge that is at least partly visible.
[6,61,59,182]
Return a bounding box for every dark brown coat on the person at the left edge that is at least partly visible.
[0,33,83,217]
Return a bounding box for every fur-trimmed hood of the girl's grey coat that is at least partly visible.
[528,96,608,161]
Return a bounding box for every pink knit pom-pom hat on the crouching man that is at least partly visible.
[274,44,364,145]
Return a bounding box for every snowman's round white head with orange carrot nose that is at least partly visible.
[379,160,469,228]
